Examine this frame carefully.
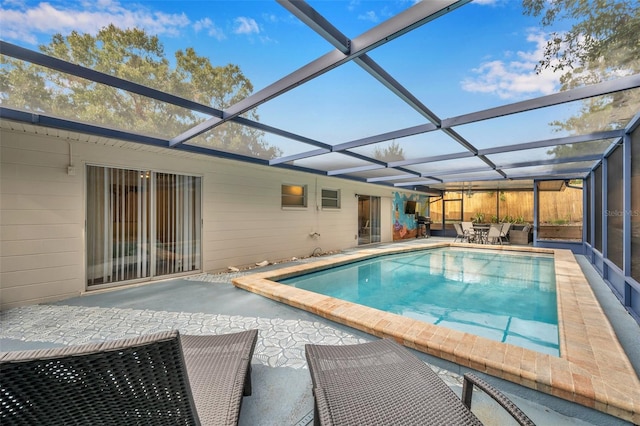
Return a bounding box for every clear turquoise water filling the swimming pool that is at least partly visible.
[280,247,559,356]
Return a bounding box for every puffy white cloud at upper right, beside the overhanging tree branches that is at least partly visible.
[461,30,559,99]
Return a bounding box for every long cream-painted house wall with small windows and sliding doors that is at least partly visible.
[0,129,404,309]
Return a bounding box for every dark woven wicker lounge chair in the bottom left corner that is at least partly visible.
[0,330,258,425]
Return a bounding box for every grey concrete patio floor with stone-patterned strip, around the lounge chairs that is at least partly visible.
[0,240,640,425]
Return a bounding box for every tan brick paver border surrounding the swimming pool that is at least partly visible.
[232,240,640,424]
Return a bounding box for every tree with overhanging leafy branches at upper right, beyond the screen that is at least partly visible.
[522,0,640,156]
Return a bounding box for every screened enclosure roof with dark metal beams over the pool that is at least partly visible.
[0,0,640,191]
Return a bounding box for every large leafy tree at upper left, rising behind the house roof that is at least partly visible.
[0,25,280,159]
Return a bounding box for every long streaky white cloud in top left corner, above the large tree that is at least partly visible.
[0,0,190,44]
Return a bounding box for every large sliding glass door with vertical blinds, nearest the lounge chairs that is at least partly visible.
[86,166,201,287]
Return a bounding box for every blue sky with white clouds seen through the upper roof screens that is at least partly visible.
[0,0,572,152]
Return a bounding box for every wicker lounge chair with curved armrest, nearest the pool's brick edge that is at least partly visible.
[305,339,533,425]
